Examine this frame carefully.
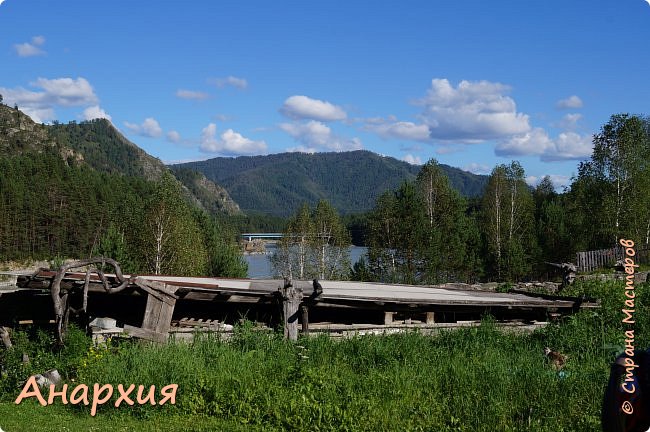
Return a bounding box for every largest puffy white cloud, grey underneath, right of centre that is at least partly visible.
[417,79,530,143]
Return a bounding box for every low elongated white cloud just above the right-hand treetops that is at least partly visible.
[494,128,593,162]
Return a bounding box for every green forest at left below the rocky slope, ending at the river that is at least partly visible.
[0,151,247,277]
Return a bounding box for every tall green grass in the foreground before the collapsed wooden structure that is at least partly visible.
[0,282,650,432]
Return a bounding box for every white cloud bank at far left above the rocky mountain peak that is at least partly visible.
[0,78,99,123]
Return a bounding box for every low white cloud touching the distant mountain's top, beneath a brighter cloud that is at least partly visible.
[280,120,363,153]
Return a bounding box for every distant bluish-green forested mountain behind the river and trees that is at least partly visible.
[171,150,487,216]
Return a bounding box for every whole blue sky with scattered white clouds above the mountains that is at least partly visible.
[0,0,650,186]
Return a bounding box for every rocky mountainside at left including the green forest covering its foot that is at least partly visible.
[0,104,246,277]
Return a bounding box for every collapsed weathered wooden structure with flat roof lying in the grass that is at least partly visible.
[0,258,598,342]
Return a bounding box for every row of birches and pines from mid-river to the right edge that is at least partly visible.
[274,114,650,284]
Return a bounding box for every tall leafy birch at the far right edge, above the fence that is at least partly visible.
[569,114,650,249]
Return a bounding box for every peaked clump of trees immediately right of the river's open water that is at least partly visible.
[359,160,481,284]
